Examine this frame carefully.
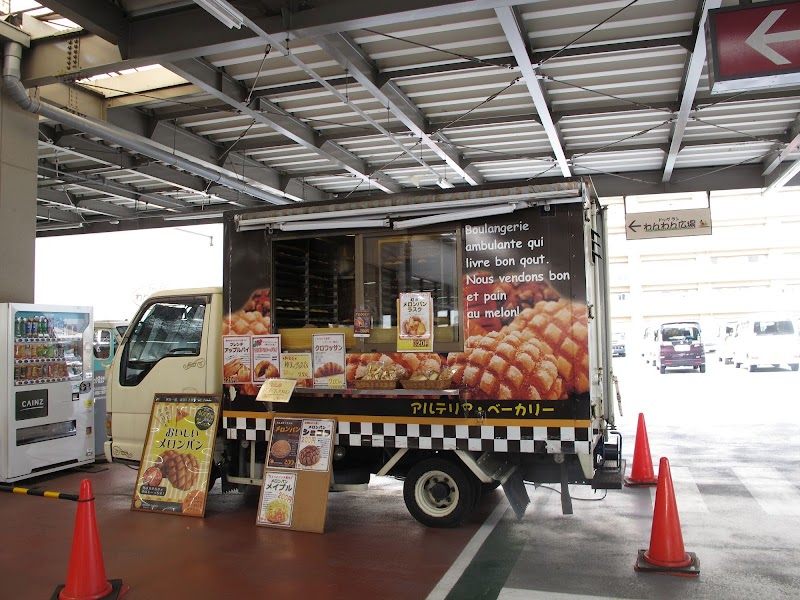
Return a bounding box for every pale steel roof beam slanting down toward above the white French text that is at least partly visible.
[495,7,572,177]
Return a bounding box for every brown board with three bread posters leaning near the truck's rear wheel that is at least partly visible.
[256,414,336,533]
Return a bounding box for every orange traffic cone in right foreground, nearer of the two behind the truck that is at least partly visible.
[633,458,700,577]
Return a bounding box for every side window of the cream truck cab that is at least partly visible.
[120,299,206,385]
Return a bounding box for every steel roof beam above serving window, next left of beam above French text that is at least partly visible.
[315,33,483,185]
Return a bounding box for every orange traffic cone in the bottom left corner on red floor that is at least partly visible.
[51,479,128,600]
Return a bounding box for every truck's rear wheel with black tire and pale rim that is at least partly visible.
[403,457,480,527]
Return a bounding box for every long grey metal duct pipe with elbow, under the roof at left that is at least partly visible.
[3,42,293,204]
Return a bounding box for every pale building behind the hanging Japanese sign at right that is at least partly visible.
[603,189,800,354]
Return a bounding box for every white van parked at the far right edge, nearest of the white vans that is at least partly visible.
[733,316,800,371]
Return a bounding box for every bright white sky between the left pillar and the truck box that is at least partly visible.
[34,225,222,320]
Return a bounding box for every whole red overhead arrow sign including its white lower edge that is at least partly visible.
[706,2,800,94]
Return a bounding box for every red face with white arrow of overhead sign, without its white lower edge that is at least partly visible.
[708,2,800,79]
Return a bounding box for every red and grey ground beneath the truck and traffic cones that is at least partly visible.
[0,358,800,600]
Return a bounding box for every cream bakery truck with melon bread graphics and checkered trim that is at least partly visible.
[106,179,625,527]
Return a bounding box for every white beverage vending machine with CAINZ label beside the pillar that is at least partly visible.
[0,303,94,482]
